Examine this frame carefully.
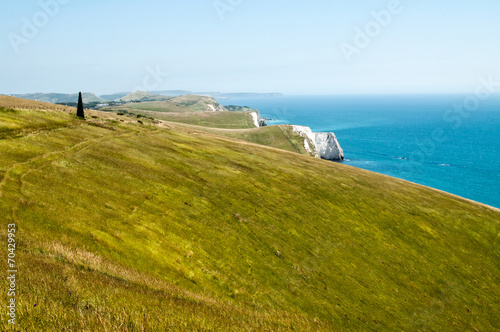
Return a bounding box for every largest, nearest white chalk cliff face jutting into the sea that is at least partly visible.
[292,126,344,160]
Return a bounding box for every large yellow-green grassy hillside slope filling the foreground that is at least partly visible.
[0,97,500,331]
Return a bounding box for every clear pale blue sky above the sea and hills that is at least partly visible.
[0,0,500,94]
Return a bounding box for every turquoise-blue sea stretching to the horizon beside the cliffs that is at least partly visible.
[219,95,500,208]
